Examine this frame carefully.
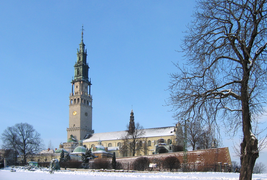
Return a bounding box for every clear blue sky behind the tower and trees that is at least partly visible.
[0,0,267,168]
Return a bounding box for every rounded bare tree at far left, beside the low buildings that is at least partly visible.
[1,123,42,164]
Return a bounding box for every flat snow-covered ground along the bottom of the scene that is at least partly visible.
[0,168,267,180]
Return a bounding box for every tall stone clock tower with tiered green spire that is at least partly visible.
[67,27,94,141]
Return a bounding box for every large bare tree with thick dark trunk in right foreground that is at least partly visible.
[170,0,267,180]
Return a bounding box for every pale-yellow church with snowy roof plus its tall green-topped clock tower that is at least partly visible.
[63,28,183,157]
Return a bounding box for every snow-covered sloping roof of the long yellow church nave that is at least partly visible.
[83,126,175,142]
